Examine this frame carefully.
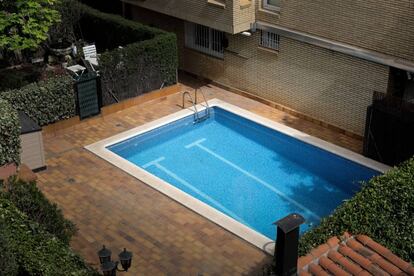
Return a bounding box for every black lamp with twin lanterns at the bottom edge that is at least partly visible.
[98,245,132,276]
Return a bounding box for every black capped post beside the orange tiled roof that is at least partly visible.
[274,214,305,276]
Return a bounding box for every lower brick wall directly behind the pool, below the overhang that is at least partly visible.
[133,5,388,135]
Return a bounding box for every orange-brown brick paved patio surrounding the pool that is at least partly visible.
[38,78,362,275]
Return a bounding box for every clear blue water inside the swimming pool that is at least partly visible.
[109,107,379,239]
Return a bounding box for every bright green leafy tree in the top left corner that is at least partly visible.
[0,0,60,51]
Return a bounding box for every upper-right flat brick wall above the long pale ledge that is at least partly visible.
[256,0,414,61]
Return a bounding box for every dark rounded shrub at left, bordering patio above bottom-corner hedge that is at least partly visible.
[4,181,76,244]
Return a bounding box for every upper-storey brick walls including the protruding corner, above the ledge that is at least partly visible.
[122,0,414,61]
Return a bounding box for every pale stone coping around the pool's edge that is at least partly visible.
[85,99,390,254]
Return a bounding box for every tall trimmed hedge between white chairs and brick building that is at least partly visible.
[100,32,176,105]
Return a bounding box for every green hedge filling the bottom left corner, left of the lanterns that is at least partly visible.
[0,196,99,276]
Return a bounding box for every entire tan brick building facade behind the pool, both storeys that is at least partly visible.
[124,0,414,135]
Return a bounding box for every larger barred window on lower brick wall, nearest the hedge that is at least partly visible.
[185,22,224,58]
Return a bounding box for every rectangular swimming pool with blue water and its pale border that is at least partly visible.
[87,100,387,252]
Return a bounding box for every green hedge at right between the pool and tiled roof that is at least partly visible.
[299,158,414,262]
